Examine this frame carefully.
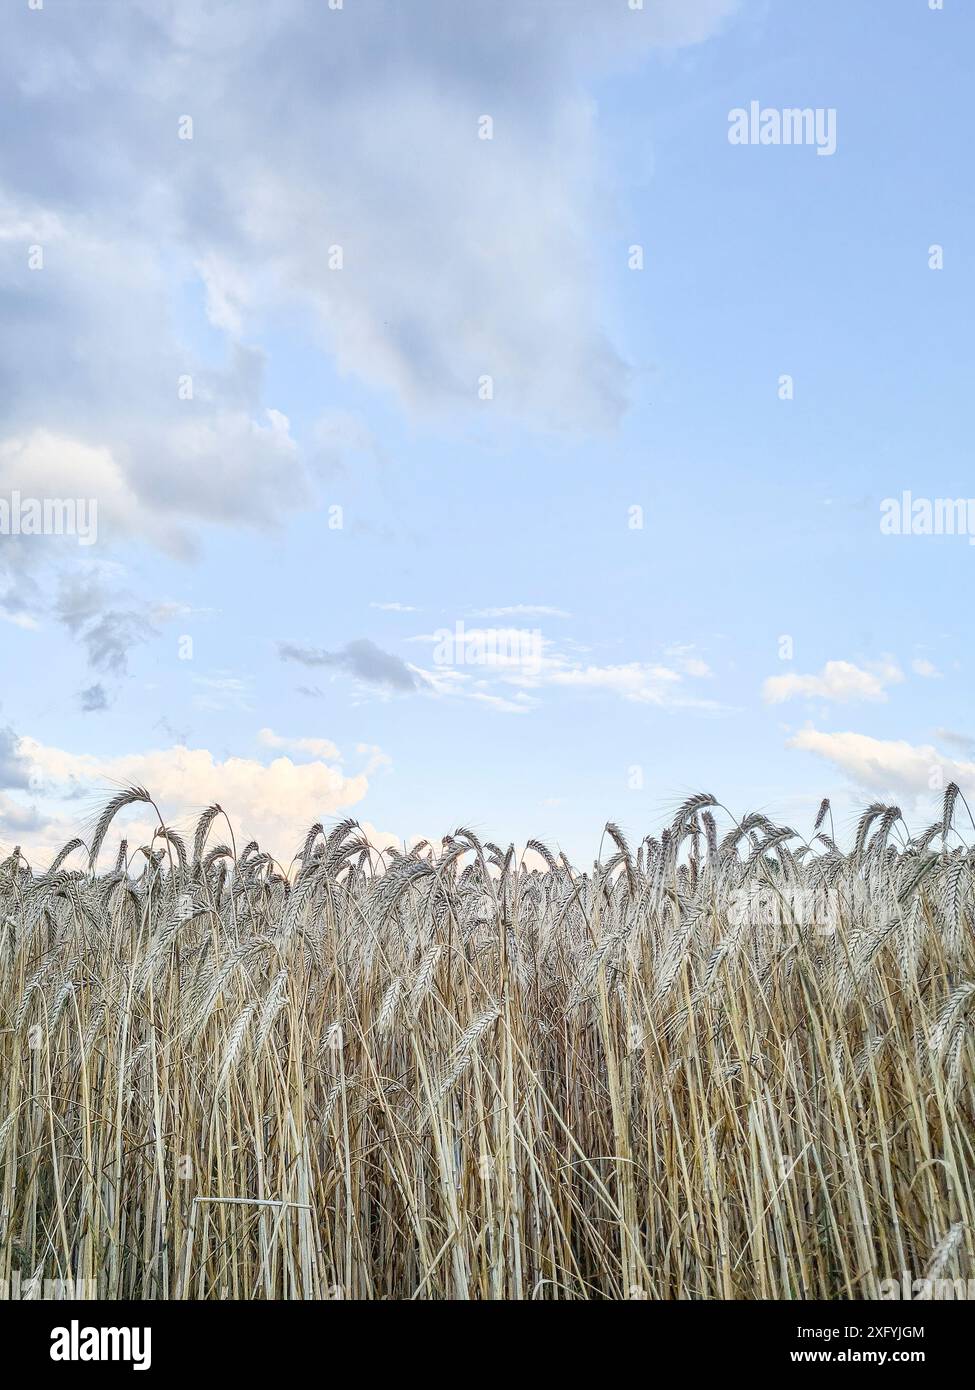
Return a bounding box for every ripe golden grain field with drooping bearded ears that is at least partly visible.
[0,785,975,1300]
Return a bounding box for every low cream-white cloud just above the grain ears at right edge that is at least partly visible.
[789,728,975,796]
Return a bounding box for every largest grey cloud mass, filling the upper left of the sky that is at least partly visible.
[0,0,734,530]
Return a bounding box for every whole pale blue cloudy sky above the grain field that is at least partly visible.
[0,0,975,866]
